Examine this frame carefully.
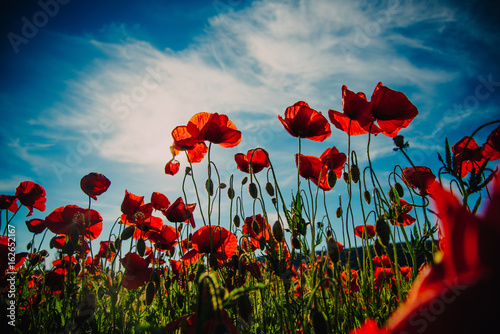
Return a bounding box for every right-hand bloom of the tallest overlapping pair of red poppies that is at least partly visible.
[371,82,418,137]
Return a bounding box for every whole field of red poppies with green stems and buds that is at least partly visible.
[0,83,500,334]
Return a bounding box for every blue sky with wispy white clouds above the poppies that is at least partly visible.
[0,0,500,256]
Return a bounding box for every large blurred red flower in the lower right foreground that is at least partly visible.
[351,170,500,333]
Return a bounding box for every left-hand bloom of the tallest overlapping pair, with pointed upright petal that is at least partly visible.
[328,85,380,136]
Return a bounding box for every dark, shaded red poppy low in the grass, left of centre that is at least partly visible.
[120,253,153,290]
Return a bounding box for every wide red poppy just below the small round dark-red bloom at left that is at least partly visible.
[45,205,102,240]
